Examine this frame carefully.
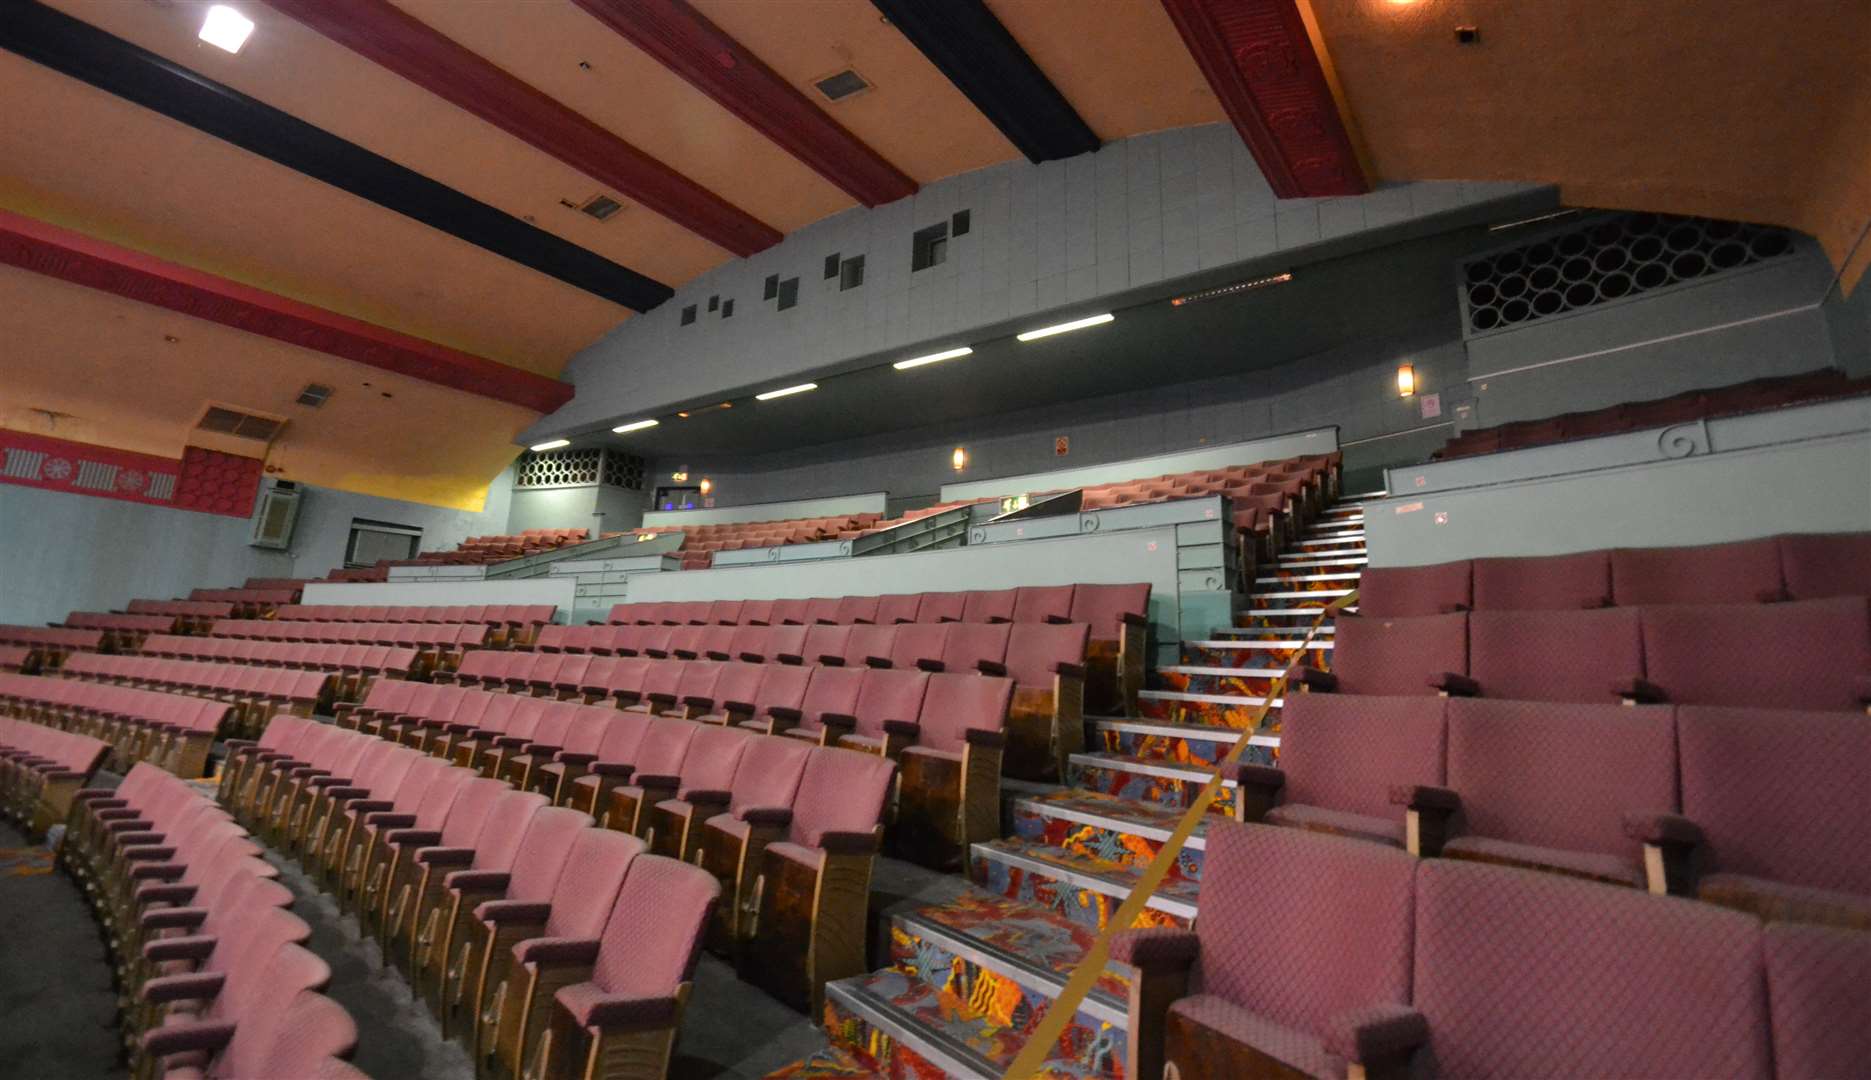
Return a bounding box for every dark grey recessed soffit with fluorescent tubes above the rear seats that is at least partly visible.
[573,189,1553,459]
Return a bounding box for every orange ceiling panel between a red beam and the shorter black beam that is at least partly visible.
[690,0,1017,183]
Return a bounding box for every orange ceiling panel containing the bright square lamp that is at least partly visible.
[51,0,728,285]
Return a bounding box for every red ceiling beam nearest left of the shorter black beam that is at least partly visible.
[568,0,917,206]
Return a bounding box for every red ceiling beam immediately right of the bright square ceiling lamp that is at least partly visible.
[268,0,780,256]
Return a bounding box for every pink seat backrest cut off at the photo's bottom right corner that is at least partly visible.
[1762,923,1871,1076]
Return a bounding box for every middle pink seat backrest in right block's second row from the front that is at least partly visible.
[1446,698,1678,865]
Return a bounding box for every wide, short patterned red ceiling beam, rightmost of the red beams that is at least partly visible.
[1162,0,1371,198]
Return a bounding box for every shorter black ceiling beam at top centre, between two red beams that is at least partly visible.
[870,0,1098,165]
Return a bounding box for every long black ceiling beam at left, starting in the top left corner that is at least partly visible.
[0,0,672,311]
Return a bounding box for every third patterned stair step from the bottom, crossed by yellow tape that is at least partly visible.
[969,840,1201,928]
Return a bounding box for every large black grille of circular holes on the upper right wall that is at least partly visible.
[1461,213,1794,337]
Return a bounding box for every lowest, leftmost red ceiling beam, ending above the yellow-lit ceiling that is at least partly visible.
[0,210,573,412]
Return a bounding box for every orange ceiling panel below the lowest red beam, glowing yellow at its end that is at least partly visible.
[0,268,537,509]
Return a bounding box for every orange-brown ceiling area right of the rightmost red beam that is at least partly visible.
[1312,0,1871,282]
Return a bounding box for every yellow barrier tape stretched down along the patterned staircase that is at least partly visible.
[1001,590,1358,1080]
